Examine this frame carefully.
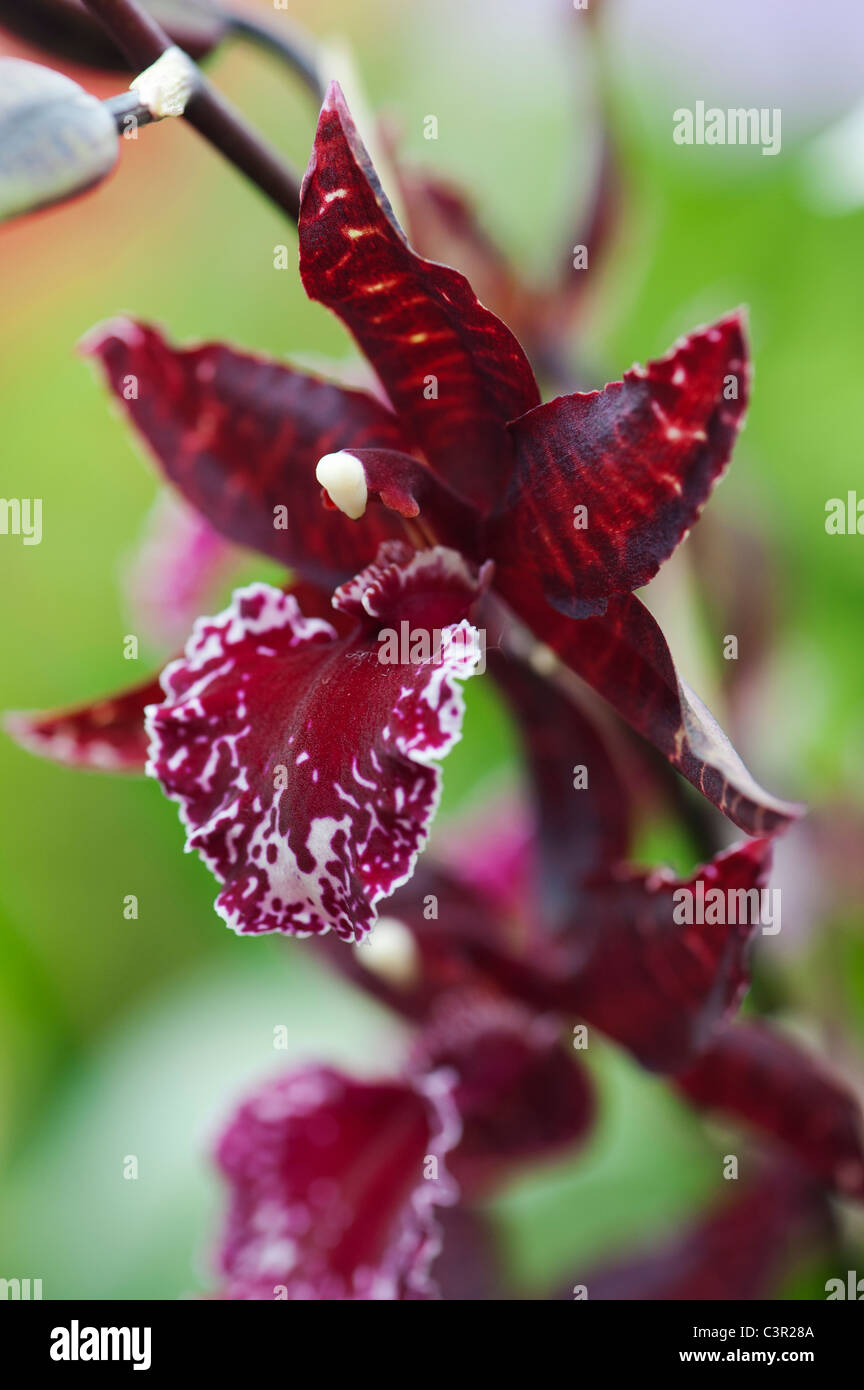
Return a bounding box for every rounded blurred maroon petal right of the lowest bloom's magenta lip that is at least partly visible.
[413,992,595,1194]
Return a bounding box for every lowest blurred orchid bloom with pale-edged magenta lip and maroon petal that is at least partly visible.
[208,995,593,1301]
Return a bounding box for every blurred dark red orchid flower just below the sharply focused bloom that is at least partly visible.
[319,660,864,1200]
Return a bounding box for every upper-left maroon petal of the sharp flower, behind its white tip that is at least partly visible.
[82,320,413,588]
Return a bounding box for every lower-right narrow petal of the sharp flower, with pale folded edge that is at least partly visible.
[520,585,804,835]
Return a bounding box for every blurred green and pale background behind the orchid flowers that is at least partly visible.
[0,0,864,1298]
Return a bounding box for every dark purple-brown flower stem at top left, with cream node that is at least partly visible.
[83,0,300,222]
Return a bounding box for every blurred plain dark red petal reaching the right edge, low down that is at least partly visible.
[675,1023,864,1198]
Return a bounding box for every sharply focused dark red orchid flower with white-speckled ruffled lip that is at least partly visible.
[6,85,800,950]
